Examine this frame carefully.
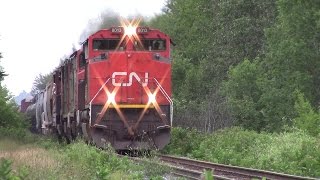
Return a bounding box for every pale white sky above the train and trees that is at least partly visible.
[0,0,166,95]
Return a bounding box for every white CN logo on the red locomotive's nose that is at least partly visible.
[112,72,149,87]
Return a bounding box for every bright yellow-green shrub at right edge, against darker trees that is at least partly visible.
[294,92,320,136]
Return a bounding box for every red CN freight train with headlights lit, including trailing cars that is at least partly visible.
[21,22,173,150]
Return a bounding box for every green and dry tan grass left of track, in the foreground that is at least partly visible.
[0,134,169,180]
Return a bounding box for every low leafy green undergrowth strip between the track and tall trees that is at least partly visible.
[165,127,320,177]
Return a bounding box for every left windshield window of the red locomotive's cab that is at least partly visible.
[93,39,123,51]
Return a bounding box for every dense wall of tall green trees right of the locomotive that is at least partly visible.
[150,0,320,134]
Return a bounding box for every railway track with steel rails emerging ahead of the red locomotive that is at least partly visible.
[158,155,316,180]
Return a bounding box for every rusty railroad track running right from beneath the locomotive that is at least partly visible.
[158,155,315,180]
